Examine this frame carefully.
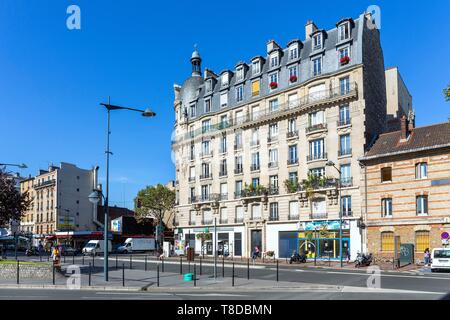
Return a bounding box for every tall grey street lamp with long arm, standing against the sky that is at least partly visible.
[96,98,156,281]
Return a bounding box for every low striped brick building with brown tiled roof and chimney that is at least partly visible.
[361,117,450,261]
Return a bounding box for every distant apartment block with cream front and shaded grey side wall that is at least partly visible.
[21,162,99,239]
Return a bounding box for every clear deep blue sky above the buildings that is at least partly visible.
[0,0,450,207]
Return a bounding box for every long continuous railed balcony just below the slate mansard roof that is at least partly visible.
[172,82,358,148]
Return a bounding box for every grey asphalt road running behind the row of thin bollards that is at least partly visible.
[20,255,450,296]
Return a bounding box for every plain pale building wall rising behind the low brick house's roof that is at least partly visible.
[386,67,414,131]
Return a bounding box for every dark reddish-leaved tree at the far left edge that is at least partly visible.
[0,170,31,226]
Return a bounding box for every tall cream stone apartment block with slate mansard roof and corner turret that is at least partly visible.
[172,14,386,259]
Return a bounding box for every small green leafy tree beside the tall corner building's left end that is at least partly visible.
[134,184,175,248]
